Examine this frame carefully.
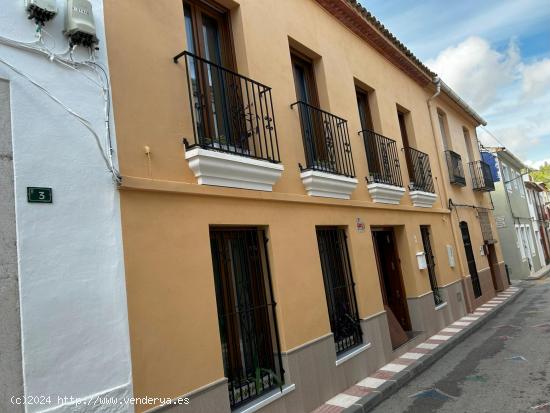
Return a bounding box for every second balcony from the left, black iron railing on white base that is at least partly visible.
[290,101,357,199]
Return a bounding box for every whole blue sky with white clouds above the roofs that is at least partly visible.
[360,0,550,168]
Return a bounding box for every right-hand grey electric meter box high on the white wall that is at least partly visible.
[64,0,98,47]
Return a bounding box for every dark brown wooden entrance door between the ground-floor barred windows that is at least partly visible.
[372,229,411,348]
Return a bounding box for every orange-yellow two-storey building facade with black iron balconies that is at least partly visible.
[105,0,507,413]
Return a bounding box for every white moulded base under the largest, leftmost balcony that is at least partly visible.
[185,148,284,191]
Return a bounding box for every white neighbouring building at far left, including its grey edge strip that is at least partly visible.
[0,0,133,413]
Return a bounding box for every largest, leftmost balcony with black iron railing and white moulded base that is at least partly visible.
[181,52,284,191]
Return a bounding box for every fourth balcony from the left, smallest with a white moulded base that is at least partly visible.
[403,147,437,208]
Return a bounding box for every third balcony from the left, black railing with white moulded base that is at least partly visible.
[359,129,405,205]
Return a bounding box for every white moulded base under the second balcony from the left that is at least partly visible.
[300,171,358,199]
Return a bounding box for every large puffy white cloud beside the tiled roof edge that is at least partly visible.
[427,37,550,164]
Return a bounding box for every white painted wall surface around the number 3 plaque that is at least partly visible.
[0,0,133,412]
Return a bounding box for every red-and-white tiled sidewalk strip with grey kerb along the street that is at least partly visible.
[312,287,523,413]
